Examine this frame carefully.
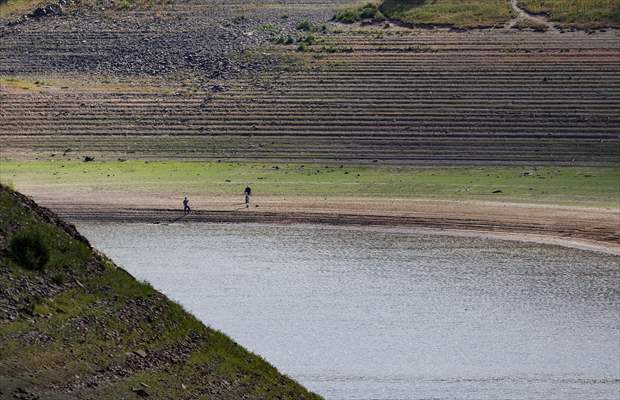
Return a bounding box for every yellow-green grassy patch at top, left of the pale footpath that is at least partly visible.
[379,0,515,29]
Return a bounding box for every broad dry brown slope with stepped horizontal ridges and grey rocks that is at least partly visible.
[0,0,620,165]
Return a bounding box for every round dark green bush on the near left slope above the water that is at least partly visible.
[9,230,50,271]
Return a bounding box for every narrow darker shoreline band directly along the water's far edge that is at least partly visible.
[53,207,620,256]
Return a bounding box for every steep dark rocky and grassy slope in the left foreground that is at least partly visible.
[0,186,319,399]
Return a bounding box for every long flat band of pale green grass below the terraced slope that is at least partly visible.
[0,161,620,206]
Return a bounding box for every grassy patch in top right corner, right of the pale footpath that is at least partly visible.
[519,0,620,29]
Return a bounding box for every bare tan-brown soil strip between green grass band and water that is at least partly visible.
[21,187,620,251]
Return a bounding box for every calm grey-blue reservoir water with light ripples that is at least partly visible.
[78,223,620,400]
